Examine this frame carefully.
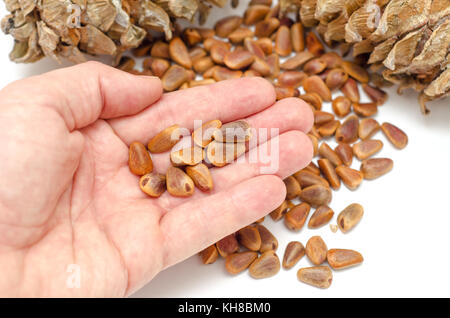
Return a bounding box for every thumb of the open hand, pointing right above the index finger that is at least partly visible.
[2,62,162,131]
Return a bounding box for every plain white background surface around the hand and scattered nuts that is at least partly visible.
[0,0,450,297]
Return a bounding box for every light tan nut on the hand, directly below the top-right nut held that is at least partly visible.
[206,141,246,167]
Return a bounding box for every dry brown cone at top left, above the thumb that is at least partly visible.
[1,0,228,63]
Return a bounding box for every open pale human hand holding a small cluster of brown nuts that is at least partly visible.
[0,62,313,297]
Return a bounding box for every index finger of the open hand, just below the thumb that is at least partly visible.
[110,77,275,144]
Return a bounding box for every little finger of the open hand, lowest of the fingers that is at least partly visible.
[160,176,286,268]
